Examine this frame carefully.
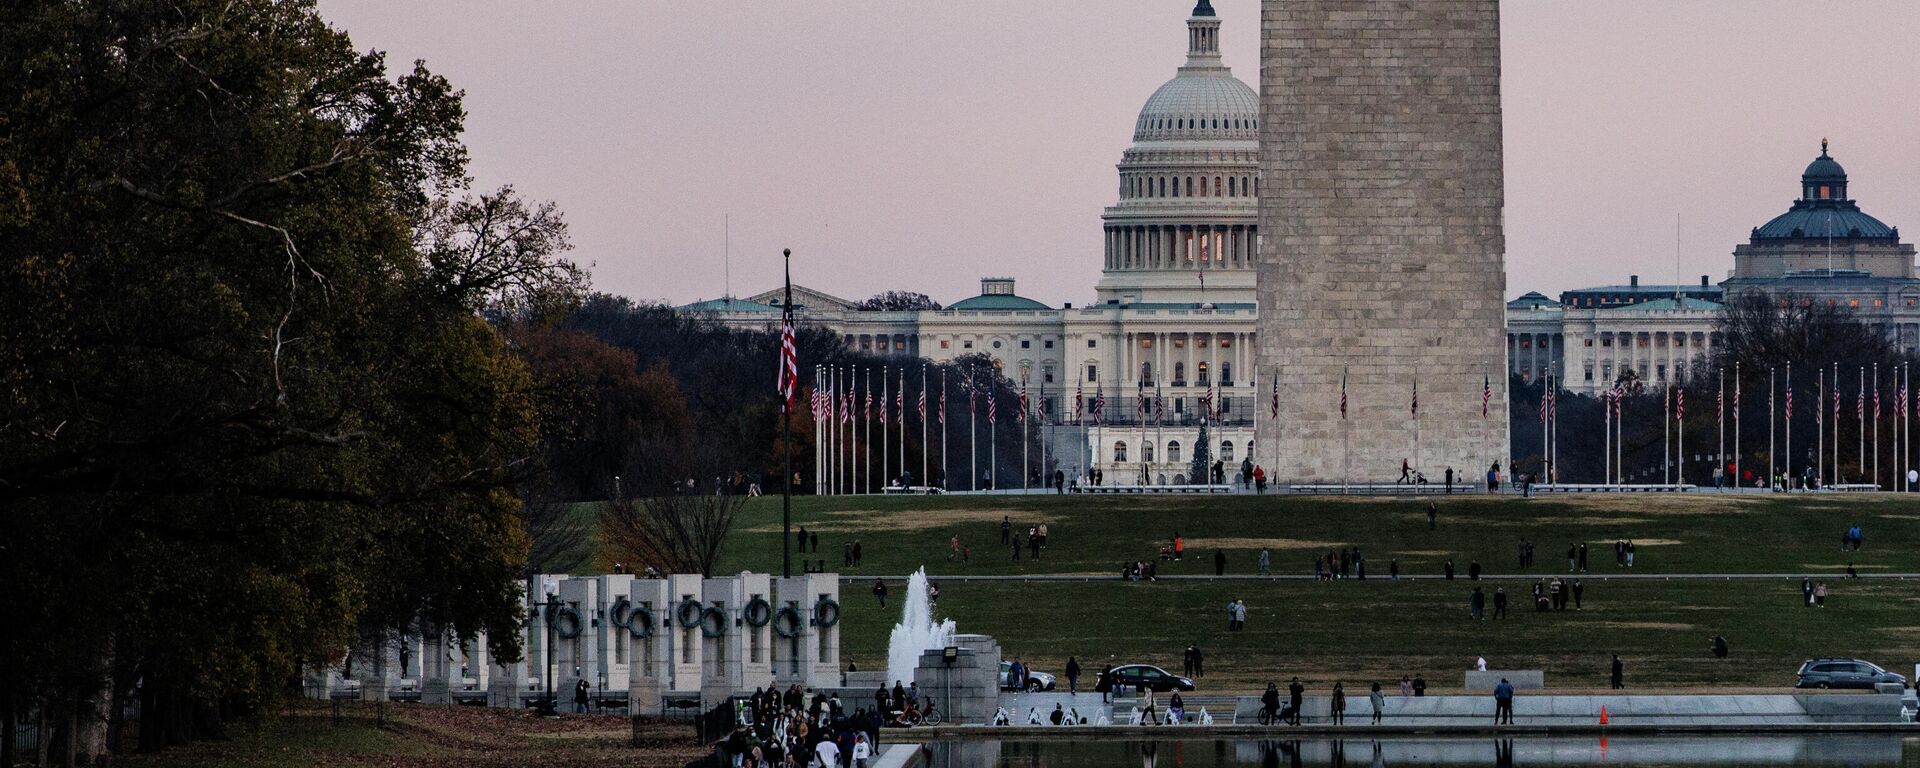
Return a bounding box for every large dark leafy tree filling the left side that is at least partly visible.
[0,0,580,749]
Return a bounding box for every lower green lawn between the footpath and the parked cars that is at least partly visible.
[843,578,1920,691]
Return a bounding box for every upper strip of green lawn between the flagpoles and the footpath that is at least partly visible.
[718,493,1920,576]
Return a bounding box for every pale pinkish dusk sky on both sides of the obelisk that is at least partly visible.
[319,0,1920,305]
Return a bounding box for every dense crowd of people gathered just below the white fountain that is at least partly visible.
[722,685,881,768]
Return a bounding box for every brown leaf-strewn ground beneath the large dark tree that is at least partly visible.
[115,701,705,768]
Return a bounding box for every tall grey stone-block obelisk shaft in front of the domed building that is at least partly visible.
[1258,0,1507,482]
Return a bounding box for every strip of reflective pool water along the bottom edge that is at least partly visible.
[925,735,1920,768]
